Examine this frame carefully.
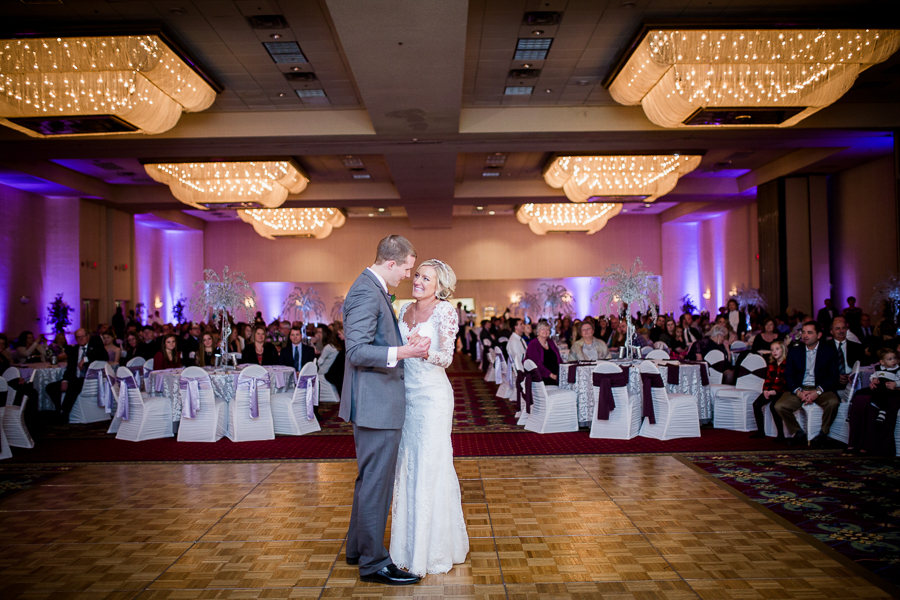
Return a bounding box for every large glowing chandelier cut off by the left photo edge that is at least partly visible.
[0,34,221,137]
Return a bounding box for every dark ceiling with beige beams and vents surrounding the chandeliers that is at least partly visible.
[0,0,900,228]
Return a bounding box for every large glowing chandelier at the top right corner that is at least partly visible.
[607,28,900,127]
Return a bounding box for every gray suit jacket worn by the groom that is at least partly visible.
[340,269,406,429]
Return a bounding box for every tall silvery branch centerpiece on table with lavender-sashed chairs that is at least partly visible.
[191,266,256,357]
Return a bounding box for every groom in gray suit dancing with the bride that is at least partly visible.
[340,235,430,585]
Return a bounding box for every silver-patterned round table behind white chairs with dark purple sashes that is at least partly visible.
[559,361,712,427]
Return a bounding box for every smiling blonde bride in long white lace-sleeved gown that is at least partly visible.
[391,259,469,575]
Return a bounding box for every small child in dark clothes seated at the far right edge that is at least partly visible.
[847,348,900,456]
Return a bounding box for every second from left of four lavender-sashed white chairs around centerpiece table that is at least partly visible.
[176,361,228,442]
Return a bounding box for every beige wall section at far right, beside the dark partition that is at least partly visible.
[828,157,898,312]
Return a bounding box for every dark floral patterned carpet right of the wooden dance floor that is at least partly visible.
[685,452,900,594]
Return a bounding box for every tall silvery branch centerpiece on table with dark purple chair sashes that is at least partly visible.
[591,257,663,356]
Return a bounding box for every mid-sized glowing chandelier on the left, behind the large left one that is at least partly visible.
[144,160,309,209]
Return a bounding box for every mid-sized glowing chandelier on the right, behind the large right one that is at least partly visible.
[544,154,702,202]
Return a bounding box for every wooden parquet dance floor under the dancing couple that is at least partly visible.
[0,456,890,600]
